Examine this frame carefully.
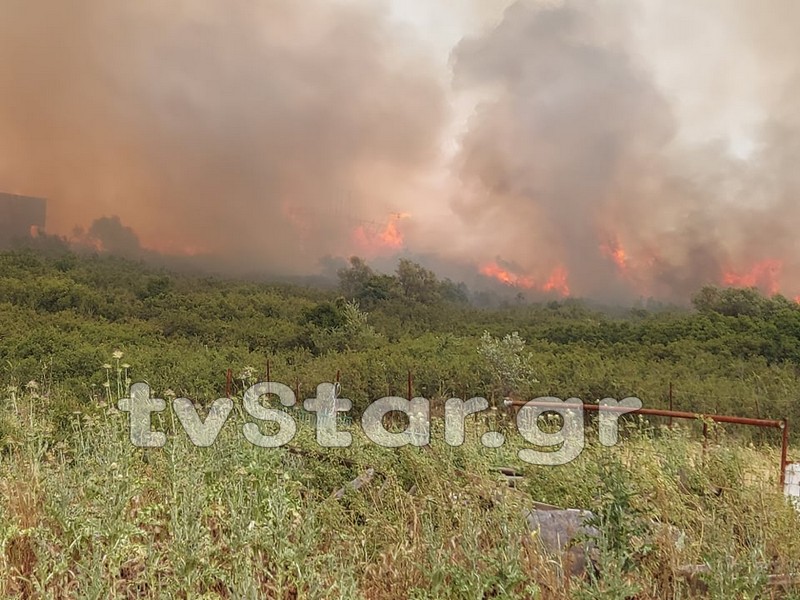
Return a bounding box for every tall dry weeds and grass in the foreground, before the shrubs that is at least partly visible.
[0,376,800,600]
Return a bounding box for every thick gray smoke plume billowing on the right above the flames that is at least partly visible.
[454,0,800,299]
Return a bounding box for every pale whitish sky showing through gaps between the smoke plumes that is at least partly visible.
[390,0,768,157]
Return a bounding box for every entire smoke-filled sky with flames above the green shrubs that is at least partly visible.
[0,0,800,301]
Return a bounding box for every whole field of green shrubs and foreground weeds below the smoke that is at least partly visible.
[0,249,800,599]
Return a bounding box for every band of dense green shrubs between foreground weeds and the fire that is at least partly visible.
[0,251,800,428]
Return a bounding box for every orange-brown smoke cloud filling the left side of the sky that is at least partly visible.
[0,0,444,272]
